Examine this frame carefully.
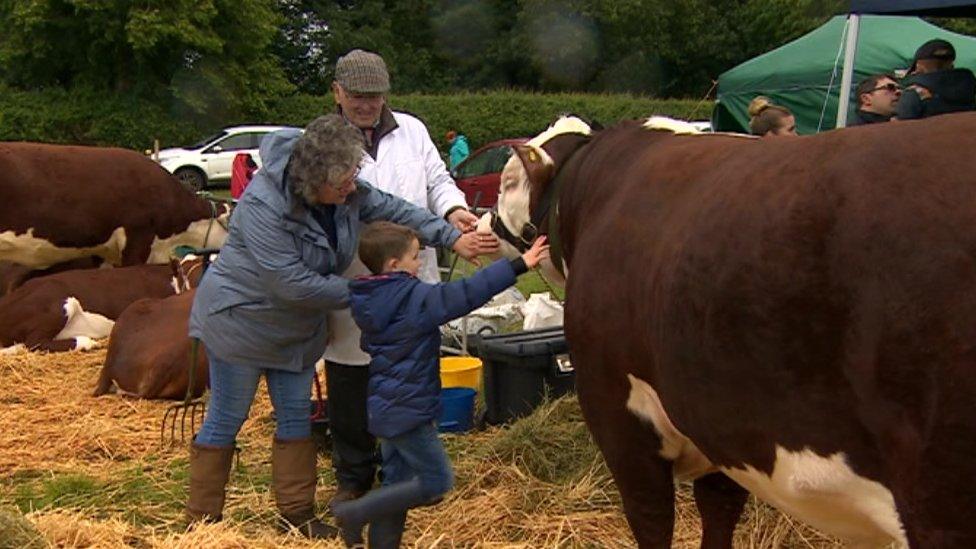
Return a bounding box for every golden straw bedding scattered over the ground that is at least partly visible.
[0,348,840,549]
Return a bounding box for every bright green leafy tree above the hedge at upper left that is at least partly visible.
[0,0,288,112]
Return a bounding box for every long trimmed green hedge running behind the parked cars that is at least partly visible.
[0,87,712,150]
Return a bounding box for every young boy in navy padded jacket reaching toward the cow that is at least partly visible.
[332,221,549,549]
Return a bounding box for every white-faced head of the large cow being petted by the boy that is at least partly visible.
[492,116,592,283]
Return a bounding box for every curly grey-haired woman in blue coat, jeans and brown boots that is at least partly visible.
[186,115,497,538]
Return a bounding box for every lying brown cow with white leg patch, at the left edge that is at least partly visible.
[0,265,177,351]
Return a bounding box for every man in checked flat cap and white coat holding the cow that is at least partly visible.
[323,49,488,501]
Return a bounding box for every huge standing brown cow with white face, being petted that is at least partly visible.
[498,113,976,548]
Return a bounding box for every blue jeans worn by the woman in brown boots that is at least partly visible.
[196,351,315,446]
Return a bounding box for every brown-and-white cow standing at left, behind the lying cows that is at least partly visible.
[0,143,228,269]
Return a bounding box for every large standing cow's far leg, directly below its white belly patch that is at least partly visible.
[695,473,749,549]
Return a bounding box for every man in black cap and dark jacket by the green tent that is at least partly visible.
[896,39,976,120]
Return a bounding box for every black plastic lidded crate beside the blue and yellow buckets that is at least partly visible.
[478,327,576,425]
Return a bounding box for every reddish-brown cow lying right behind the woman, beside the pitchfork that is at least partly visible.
[95,254,216,399]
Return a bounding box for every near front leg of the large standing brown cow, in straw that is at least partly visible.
[577,378,674,548]
